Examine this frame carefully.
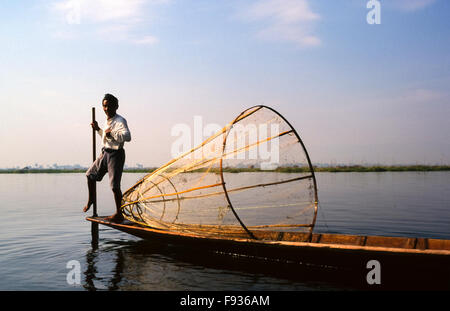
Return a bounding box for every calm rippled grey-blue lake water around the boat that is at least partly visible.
[0,172,450,290]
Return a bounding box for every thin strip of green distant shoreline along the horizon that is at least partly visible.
[0,165,450,174]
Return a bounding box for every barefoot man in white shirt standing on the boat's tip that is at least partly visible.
[83,94,131,222]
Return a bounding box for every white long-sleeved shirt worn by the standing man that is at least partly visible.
[97,113,131,150]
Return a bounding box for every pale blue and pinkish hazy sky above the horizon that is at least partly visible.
[0,0,450,167]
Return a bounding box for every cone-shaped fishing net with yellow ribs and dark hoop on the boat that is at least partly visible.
[122,106,317,238]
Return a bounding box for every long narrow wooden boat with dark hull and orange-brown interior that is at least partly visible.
[87,217,450,289]
